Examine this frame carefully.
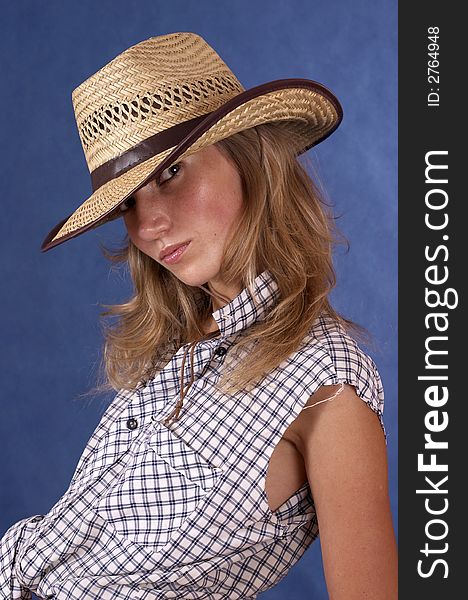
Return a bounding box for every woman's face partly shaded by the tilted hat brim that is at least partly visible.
[121,145,243,289]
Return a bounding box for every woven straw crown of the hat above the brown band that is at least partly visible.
[72,33,244,172]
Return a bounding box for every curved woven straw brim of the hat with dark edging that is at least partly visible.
[41,79,343,252]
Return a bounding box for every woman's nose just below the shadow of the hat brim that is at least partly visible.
[134,186,171,242]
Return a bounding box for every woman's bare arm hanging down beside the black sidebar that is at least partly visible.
[288,385,397,600]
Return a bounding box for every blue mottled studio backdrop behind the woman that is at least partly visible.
[0,0,397,600]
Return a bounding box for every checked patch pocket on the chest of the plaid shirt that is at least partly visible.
[97,424,222,550]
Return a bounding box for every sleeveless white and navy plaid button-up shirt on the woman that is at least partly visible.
[0,271,383,600]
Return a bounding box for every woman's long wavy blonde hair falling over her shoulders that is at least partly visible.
[102,123,362,392]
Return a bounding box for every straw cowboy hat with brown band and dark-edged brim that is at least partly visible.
[41,33,342,251]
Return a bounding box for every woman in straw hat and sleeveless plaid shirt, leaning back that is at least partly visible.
[0,33,396,600]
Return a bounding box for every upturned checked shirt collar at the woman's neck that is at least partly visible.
[212,271,279,337]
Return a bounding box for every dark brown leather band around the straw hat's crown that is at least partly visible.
[91,115,208,192]
